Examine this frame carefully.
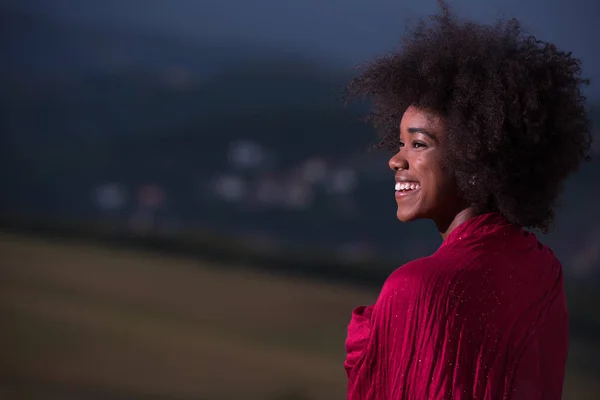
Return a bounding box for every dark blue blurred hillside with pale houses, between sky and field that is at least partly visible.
[0,9,600,281]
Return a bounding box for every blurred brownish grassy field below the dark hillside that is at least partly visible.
[0,233,600,400]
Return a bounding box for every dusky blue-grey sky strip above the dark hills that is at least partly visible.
[3,0,600,99]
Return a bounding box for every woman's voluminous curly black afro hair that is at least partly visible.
[347,2,592,232]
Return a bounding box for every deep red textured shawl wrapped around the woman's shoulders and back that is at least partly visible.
[344,213,568,400]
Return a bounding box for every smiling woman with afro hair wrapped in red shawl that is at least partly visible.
[345,5,591,400]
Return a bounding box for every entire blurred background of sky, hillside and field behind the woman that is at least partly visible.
[0,0,600,400]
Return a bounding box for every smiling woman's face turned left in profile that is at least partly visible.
[389,106,464,226]
